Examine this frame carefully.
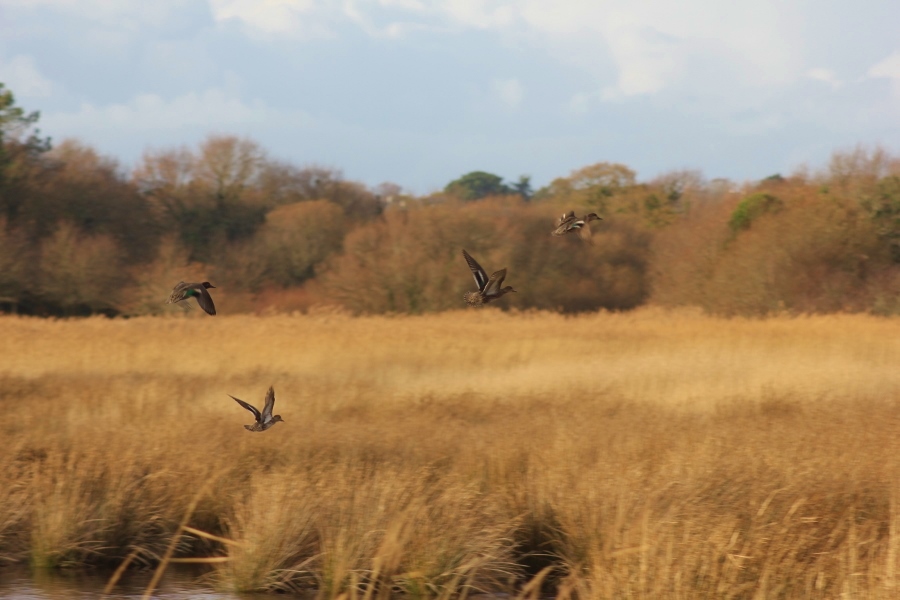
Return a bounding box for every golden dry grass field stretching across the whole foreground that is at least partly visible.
[0,309,900,600]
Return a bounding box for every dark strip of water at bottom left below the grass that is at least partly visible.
[0,568,274,600]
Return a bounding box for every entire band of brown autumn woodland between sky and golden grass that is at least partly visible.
[0,84,900,316]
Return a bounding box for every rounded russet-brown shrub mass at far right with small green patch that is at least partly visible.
[654,182,900,315]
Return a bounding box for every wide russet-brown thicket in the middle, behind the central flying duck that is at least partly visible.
[317,198,649,313]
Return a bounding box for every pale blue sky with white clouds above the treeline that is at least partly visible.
[0,0,900,193]
